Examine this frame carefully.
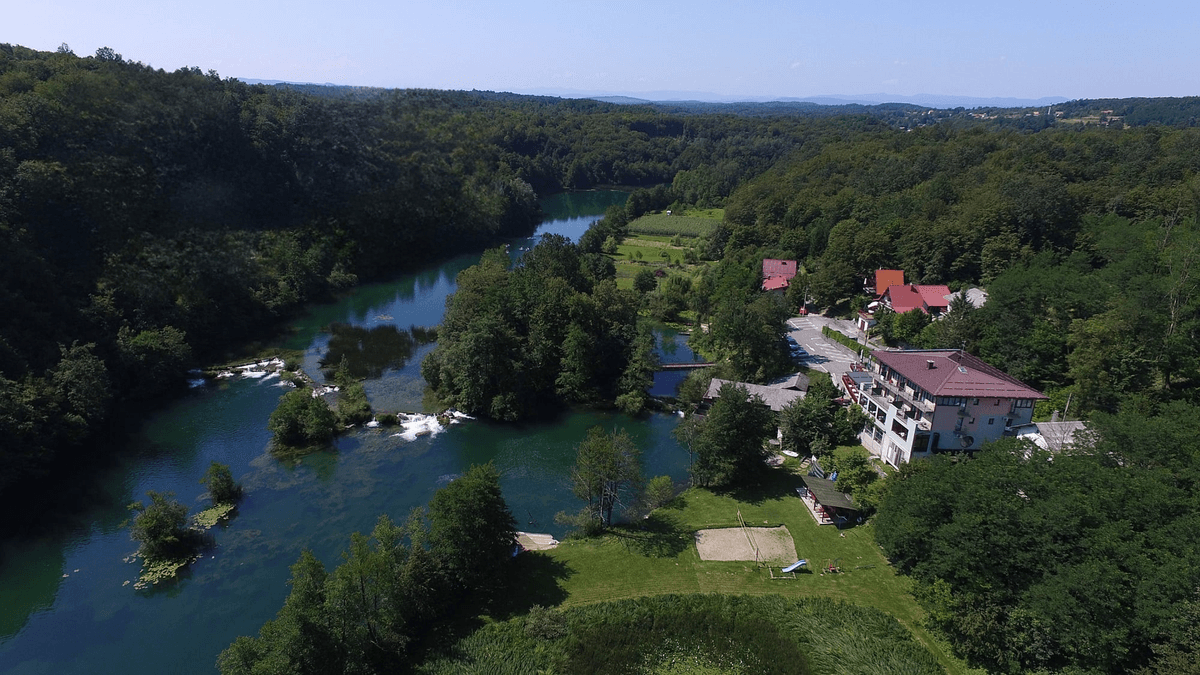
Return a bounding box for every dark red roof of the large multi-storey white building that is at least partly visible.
[871,350,1046,399]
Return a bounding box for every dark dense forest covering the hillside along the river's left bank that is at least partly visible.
[0,44,840,511]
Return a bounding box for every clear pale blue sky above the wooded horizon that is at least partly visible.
[9,0,1200,98]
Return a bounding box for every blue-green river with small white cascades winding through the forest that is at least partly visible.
[0,187,694,675]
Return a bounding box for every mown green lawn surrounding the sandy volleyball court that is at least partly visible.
[530,467,968,673]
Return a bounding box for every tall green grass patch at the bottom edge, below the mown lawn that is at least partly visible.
[419,595,942,675]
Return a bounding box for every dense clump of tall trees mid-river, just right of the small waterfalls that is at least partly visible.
[421,235,658,420]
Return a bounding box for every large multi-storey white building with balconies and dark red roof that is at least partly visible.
[854,350,1046,466]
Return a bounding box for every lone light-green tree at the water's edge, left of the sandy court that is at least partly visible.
[571,426,642,527]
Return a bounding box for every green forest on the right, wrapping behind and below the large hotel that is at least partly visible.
[700,127,1200,674]
